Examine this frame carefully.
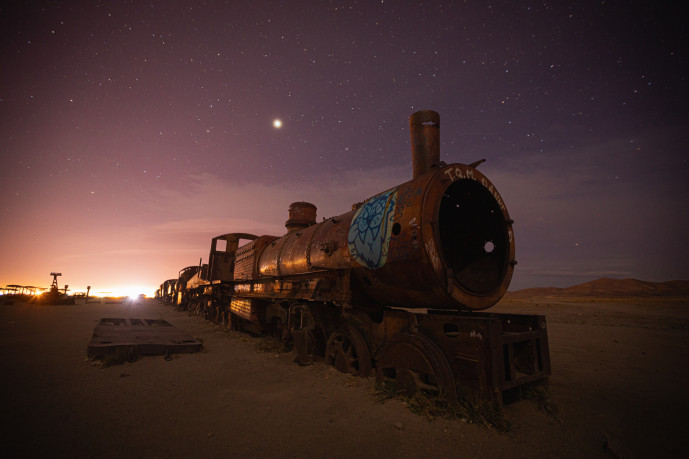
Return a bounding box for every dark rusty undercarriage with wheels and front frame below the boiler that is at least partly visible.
[180,282,550,406]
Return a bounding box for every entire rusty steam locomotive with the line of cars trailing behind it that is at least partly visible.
[161,110,550,403]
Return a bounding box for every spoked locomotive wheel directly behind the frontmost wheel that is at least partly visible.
[325,325,371,378]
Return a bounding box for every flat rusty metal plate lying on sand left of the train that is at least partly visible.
[86,318,202,360]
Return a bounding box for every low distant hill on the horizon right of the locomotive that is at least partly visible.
[509,278,689,297]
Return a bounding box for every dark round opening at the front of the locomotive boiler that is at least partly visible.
[438,180,509,294]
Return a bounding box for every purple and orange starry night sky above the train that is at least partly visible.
[0,0,689,294]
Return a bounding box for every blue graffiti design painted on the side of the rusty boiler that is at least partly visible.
[348,190,397,269]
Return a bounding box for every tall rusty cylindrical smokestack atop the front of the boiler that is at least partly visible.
[409,110,440,178]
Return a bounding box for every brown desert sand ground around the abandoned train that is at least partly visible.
[0,295,689,458]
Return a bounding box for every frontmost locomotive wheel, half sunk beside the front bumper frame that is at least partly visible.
[376,335,457,404]
